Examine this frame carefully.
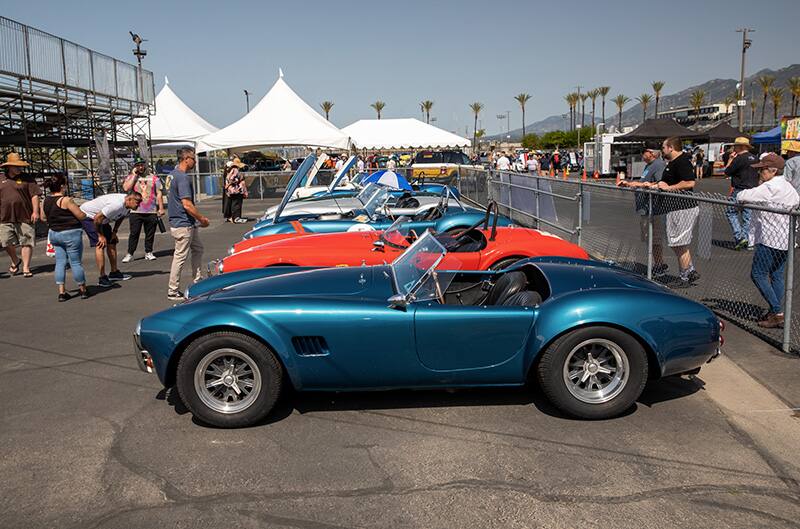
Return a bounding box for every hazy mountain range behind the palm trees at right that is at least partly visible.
[487,64,800,141]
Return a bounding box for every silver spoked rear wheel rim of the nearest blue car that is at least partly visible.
[563,338,630,404]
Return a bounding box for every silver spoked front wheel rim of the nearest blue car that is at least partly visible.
[194,349,261,414]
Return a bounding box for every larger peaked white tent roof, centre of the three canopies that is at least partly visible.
[197,72,350,152]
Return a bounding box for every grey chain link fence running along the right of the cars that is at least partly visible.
[459,168,800,353]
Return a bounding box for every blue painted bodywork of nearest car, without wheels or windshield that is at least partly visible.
[140,258,719,390]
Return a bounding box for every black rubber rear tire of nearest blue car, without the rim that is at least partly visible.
[538,326,648,419]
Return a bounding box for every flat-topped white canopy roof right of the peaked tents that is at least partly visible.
[342,118,470,149]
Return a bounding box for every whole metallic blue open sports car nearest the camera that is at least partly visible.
[134,232,721,427]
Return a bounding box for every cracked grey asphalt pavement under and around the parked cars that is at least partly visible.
[0,196,800,529]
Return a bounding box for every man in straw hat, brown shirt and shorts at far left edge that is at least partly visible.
[0,152,42,277]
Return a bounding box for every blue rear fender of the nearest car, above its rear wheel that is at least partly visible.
[526,288,719,376]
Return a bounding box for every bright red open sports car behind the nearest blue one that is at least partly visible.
[215,213,589,273]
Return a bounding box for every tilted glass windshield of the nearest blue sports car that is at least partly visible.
[392,231,460,302]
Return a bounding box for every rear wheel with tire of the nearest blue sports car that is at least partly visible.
[538,326,648,419]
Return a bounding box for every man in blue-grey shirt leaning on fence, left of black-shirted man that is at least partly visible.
[619,148,669,277]
